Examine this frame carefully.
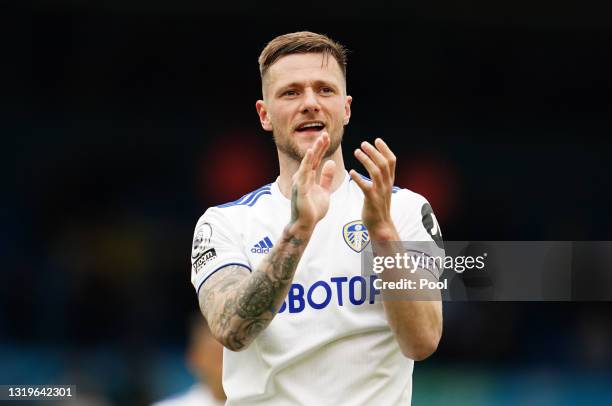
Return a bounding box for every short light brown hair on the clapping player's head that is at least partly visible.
[259,31,347,80]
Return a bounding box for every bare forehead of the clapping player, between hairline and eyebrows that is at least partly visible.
[265,53,344,87]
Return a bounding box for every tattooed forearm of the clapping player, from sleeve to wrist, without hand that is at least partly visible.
[199,226,309,351]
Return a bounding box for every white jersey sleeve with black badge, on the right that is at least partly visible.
[394,189,445,278]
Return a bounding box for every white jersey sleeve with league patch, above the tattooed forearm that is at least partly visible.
[191,207,251,292]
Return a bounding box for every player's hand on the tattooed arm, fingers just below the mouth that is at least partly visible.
[289,131,336,232]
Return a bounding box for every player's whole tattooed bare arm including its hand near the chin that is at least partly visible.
[198,133,334,351]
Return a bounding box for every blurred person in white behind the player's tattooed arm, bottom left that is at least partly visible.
[153,314,225,406]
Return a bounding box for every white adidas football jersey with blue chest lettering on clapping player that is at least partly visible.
[191,172,441,405]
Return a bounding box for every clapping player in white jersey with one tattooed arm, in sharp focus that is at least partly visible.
[191,32,442,405]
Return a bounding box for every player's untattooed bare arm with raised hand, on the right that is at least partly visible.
[351,139,442,361]
